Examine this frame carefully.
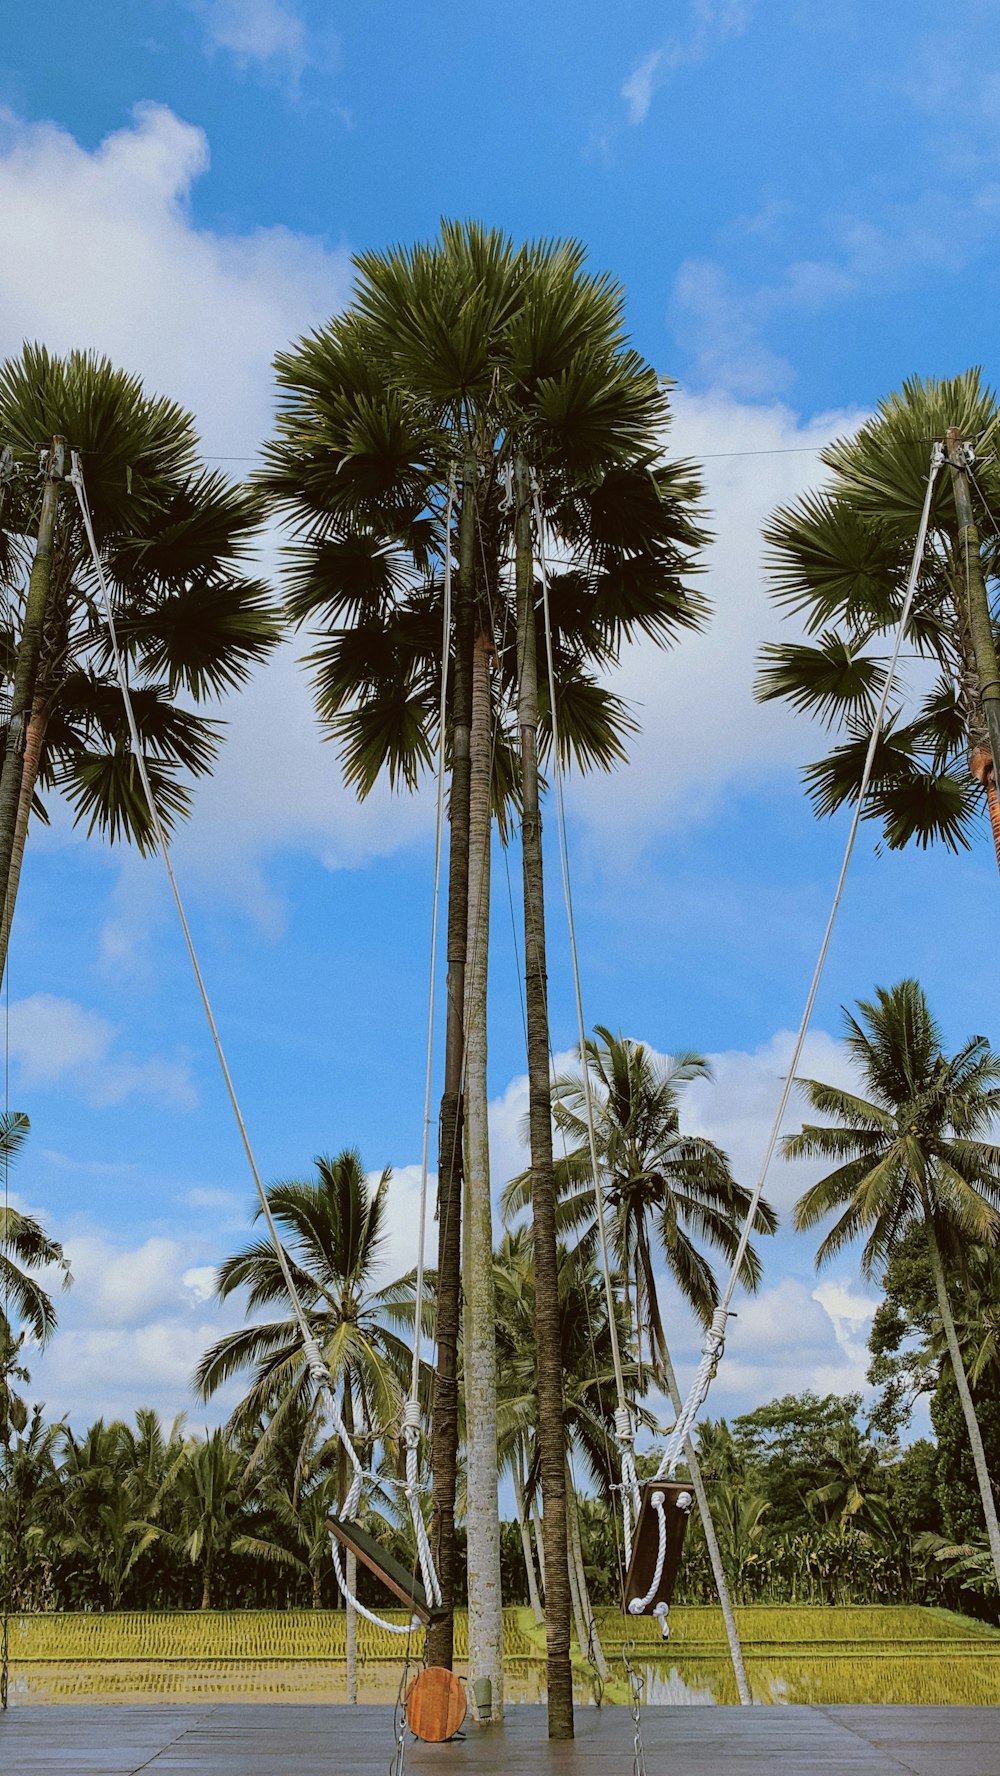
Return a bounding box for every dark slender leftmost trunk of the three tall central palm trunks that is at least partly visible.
[426,462,476,1669]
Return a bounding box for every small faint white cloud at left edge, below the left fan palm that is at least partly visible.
[11,993,197,1110]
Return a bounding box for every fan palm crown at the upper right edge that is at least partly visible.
[757,369,1000,865]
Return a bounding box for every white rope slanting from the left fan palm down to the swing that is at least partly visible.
[69,451,440,1630]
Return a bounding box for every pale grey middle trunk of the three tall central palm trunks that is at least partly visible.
[462,634,503,1719]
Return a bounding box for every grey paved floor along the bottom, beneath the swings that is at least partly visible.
[0,1703,1000,1776]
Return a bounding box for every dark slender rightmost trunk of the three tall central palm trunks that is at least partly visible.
[517,462,574,1739]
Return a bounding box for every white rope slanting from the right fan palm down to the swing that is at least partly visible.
[657,444,945,1479]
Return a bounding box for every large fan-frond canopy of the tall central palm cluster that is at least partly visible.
[259,222,709,817]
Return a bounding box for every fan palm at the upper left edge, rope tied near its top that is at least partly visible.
[0,345,279,973]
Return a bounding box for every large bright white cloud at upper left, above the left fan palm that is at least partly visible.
[0,103,348,469]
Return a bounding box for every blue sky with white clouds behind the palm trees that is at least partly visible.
[0,0,1000,1423]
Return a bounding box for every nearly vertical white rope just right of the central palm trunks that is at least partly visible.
[531,476,639,1561]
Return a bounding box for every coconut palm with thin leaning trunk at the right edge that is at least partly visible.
[783,980,1000,1590]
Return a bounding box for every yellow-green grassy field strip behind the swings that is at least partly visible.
[11,1606,1000,1705]
